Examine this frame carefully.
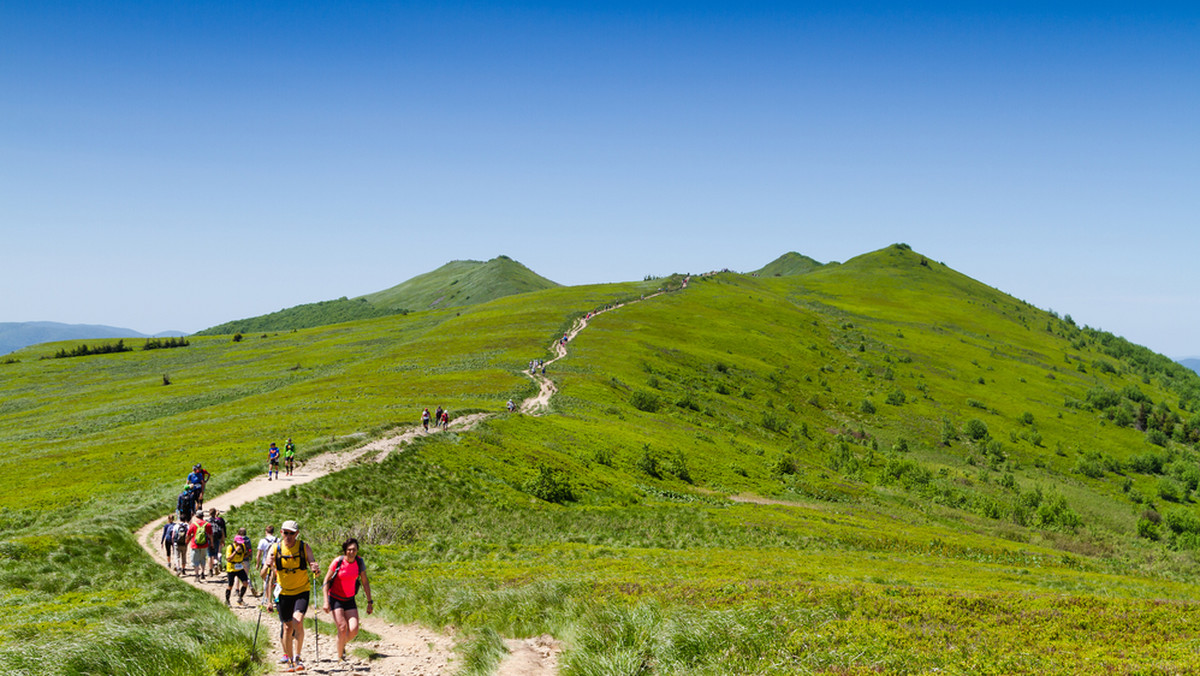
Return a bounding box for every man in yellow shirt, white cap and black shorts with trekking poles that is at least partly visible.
[263,520,320,672]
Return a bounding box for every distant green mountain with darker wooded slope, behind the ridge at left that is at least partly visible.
[197,256,559,335]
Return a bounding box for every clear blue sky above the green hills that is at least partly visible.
[0,0,1200,358]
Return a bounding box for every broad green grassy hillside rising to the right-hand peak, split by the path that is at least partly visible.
[0,245,1200,674]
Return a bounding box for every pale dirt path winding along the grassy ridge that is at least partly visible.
[134,289,686,676]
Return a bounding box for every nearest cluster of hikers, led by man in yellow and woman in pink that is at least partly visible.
[160,485,374,672]
